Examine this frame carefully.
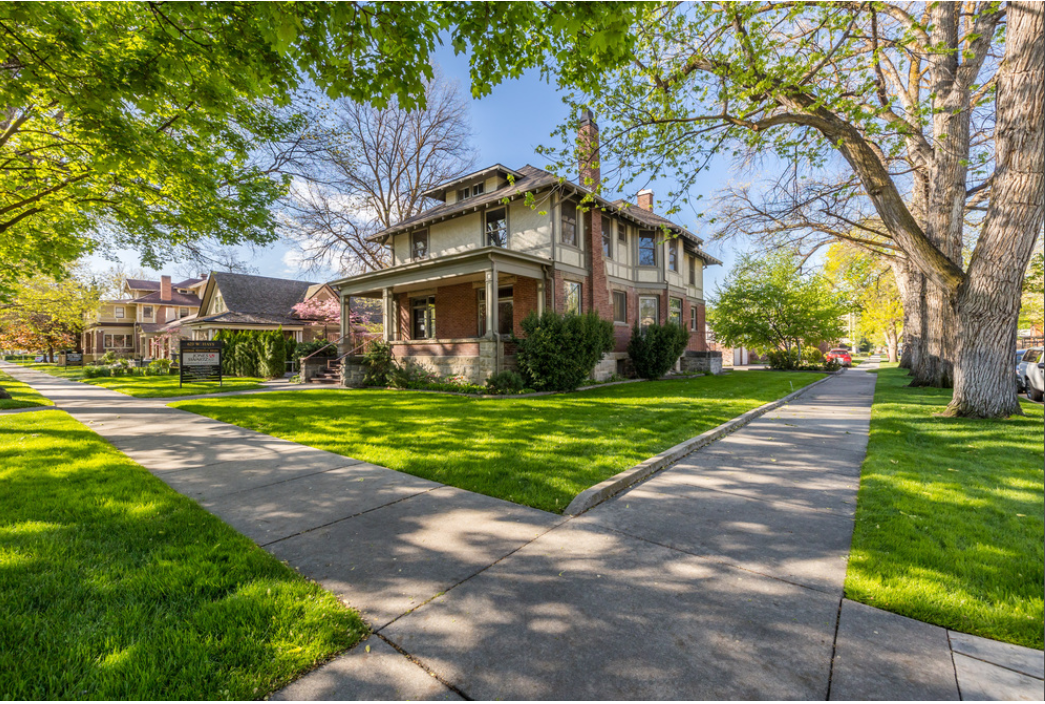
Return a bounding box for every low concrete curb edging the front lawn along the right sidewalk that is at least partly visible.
[562,374,835,516]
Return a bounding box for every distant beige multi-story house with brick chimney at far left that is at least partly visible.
[82,276,206,361]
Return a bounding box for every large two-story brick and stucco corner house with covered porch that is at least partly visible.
[330,113,721,381]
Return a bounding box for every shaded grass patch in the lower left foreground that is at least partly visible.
[0,412,366,700]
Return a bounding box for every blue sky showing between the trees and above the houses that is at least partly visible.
[91,42,741,296]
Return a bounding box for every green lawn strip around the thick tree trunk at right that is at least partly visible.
[845,368,1045,649]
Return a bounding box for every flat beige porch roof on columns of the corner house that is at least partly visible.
[330,247,552,298]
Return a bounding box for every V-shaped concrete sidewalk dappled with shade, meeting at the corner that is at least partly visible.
[4,365,1043,699]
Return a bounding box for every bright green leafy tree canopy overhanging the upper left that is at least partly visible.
[0,2,635,294]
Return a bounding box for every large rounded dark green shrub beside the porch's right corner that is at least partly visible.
[515,311,613,391]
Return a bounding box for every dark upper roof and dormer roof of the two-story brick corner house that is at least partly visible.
[368,164,722,264]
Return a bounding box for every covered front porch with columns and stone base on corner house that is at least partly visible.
[332,248,553,383]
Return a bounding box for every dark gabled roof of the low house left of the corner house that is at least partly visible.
[192,272,325,325]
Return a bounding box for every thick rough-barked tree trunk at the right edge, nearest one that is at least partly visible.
[947,2,1045,418]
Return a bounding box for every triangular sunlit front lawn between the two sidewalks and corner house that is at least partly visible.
[173,372,822,512]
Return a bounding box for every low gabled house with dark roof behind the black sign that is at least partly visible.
[179,272,339,343]
